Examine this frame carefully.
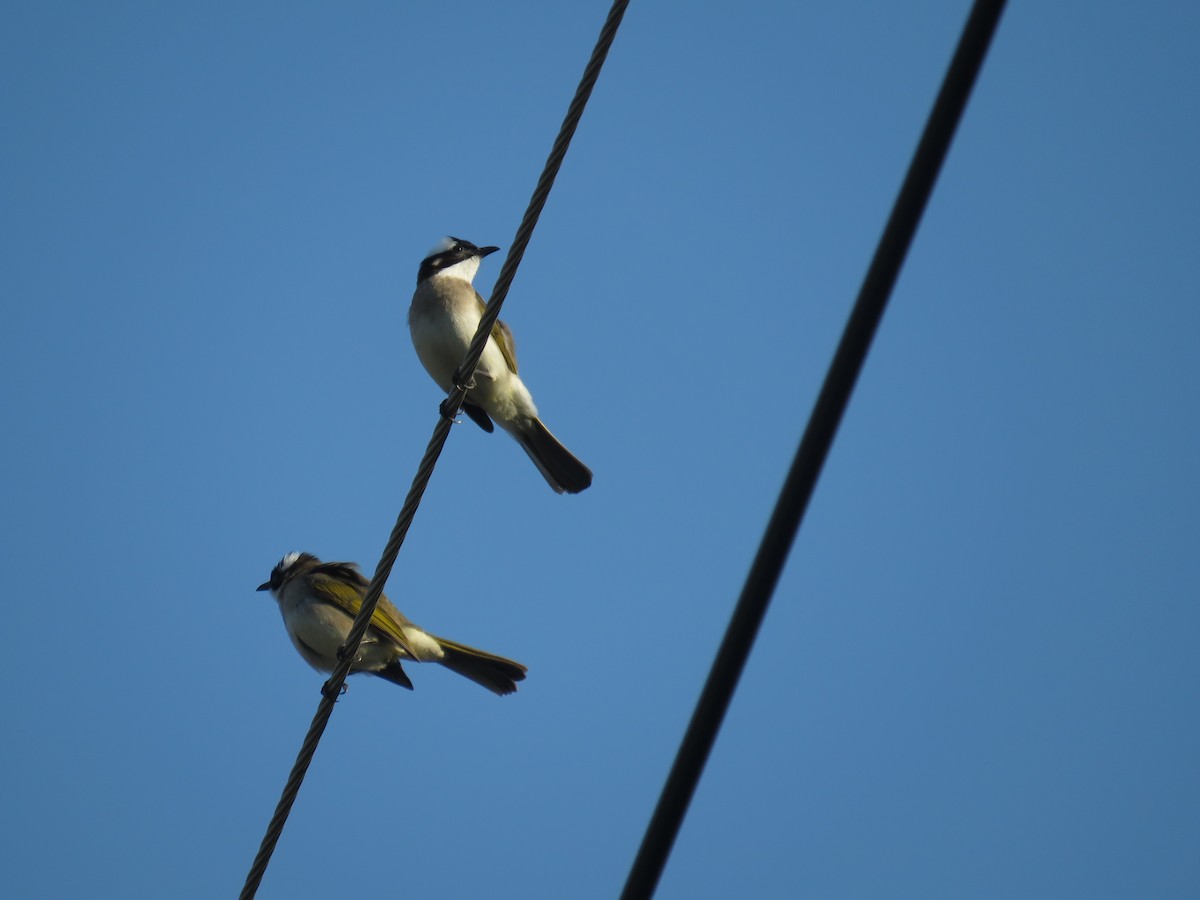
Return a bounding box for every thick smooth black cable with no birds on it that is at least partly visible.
[622,0,1004,900]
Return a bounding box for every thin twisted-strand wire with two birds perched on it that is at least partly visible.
[240,0,629,900]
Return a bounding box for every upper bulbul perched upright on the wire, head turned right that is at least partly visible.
[408,238,592,493]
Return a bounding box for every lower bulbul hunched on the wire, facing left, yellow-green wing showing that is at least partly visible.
[258,553,526,695]
